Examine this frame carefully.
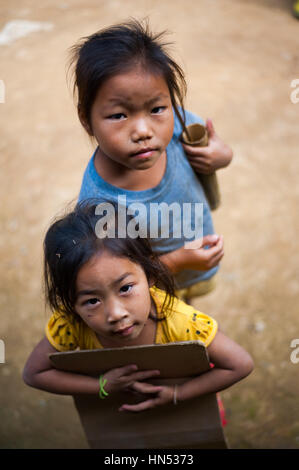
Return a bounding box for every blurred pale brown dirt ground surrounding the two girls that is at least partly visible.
[0,0,299,449]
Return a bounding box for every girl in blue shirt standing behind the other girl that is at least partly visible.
[71,20,232,299]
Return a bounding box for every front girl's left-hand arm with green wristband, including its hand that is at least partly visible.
[23,337,159,395]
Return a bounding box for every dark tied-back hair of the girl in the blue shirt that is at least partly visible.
[70,19,187,131]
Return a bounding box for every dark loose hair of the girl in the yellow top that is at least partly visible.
[44,199,175,318]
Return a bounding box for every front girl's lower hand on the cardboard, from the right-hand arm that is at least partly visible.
[119,382,174,412]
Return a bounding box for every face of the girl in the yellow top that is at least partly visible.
[75,251,154,347]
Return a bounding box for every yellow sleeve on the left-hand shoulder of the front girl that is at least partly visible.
[45,312,79,351]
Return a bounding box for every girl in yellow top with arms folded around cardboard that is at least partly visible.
[23,203,253,412]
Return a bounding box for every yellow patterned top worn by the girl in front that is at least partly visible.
[46,287,218,351]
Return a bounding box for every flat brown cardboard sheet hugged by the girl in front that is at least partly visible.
[50,341,227,449]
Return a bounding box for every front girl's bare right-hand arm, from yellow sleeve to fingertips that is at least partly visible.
[121,331,253,411]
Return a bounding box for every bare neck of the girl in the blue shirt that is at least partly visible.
[94,148,167,191]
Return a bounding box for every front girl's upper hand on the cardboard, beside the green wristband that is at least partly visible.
[103,365,160,393]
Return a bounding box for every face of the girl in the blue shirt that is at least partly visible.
[85,66,174,170]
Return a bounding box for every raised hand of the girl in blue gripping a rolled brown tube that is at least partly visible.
[182,119,233,175]
